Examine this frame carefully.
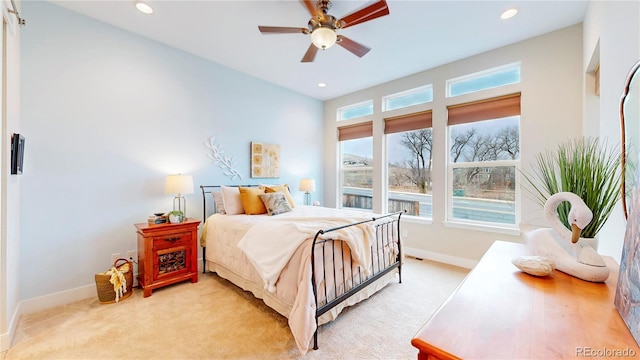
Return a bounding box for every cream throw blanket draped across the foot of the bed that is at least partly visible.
[238,217,374,293]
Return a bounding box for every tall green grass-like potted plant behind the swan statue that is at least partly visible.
[522,137,621,238]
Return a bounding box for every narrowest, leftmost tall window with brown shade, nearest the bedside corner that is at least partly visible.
[338,122,373,210]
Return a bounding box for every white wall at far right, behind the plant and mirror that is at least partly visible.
[583,1,640,262]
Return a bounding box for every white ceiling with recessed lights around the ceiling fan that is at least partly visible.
[48,0,588,100]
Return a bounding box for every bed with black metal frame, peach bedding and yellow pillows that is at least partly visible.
[200,185,403,354]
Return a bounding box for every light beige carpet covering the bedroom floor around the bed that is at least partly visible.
[2,258,467,360]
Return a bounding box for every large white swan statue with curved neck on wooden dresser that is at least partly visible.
[521,192,609,282]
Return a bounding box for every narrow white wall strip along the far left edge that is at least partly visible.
[0,1,22,351]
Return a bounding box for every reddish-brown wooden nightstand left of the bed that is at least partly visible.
[135,219,200,297]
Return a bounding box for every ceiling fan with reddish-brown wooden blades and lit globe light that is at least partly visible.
[258,0,389,62]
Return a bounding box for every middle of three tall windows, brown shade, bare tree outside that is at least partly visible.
[384,110,433,218]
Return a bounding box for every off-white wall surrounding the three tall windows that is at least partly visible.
[324,24,583,266]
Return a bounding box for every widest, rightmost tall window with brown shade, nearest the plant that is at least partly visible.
[447,93,520,225]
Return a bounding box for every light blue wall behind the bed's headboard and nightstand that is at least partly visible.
[20,1,323,300]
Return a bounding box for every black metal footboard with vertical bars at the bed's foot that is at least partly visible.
[311,211,406,350]
